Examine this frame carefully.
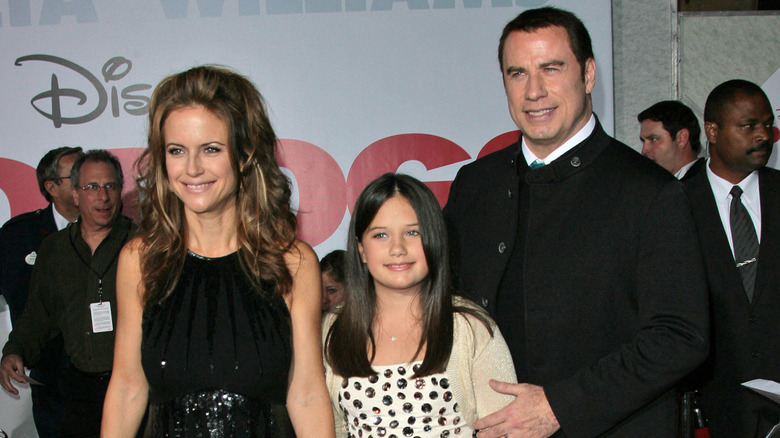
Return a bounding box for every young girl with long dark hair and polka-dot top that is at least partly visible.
[323,173,516,438]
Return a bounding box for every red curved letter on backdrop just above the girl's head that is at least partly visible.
[347,134,471,211]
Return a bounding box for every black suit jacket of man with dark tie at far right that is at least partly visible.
[685,168,780,438]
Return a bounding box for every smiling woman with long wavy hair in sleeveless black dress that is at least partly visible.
[102,66,333,438]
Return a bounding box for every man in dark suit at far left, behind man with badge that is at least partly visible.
[0,147,81,437]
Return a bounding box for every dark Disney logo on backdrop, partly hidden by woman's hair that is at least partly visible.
[14,55,152,128]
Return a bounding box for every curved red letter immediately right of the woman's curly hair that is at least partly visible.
[279,139,346,246]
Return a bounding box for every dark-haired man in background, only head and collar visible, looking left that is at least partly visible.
[636,100,704,180]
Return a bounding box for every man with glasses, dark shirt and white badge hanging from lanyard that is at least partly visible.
[0,150,136,437]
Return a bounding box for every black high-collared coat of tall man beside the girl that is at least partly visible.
[444,120,709,437]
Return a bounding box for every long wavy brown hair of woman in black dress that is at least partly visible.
[136,65,296,305]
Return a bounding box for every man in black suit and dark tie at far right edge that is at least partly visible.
[685,80,780,438]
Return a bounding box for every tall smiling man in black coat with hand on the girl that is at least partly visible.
[444,8,709,438]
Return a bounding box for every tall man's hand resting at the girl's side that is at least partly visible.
[474,380,561,438]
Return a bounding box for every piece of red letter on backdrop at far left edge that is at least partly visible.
[0,158,46,217]
